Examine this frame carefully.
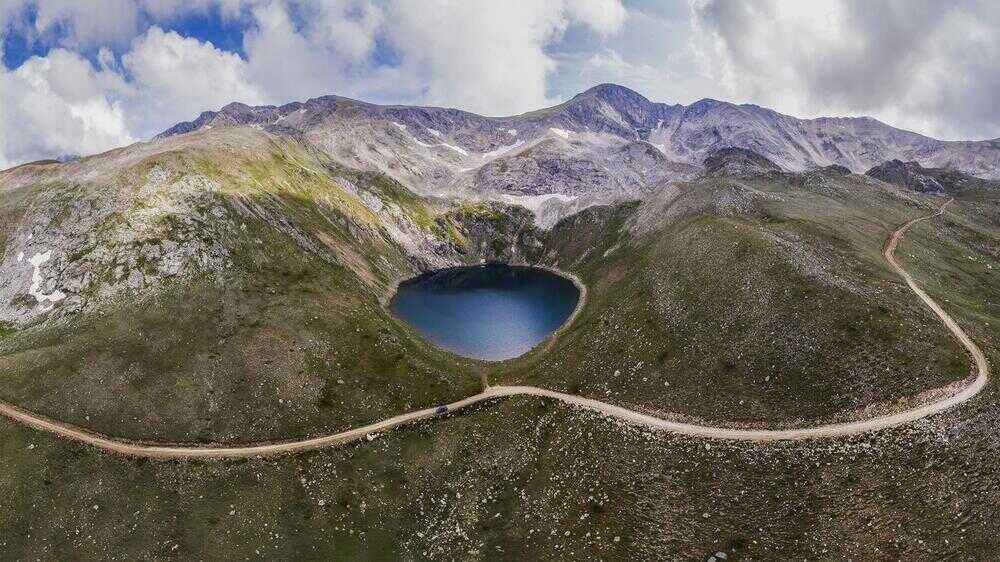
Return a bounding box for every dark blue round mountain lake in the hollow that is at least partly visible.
[389,264,580,361]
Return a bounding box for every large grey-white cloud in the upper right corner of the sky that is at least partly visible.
[692,0,1000,138]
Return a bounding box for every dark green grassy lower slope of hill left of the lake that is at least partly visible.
[0,147,480,442]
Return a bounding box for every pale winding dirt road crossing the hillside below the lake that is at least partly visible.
[0,199,989,459]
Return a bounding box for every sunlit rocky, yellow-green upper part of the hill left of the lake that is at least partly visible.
[0,128,556,324]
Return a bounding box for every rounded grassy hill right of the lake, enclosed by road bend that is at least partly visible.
[493,173,970,427]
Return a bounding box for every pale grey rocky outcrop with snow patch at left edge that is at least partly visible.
[0,167,239,323]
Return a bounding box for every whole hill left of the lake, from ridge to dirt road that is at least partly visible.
[0,129,480,442]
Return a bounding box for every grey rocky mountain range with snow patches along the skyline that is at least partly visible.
[160,84,1000,201]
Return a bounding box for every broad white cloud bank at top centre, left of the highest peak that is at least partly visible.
[238,0,625,115]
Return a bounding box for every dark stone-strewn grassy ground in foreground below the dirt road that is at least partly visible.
[0,360,1000,560]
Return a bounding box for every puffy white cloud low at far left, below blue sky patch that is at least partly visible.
[0,27,266,169]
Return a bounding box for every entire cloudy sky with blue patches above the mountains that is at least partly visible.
[0,0,1000,169]
